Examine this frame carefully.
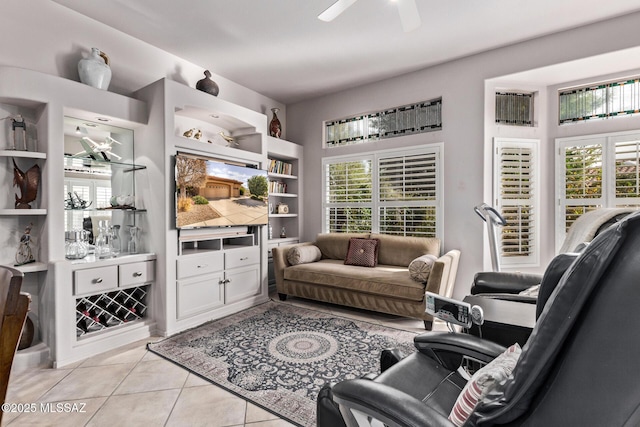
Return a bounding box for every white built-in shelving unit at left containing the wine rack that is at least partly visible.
[0,67,155,370]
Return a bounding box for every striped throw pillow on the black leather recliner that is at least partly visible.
[449,343,522,426]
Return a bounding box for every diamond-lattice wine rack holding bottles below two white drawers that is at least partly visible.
[76,285,149,337]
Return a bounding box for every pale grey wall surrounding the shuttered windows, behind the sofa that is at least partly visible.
[287,10,640,298]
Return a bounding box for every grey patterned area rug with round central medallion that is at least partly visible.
[148,301,415,427]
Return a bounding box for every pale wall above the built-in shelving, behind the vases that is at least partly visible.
[0,0,286,128]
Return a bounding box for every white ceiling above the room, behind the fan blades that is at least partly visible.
[54,0,640,104]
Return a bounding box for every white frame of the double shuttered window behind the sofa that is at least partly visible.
[321,142,444,241]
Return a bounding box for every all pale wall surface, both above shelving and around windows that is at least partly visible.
[0,0,640,297]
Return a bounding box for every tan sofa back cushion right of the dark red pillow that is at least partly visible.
[371,234,440,267]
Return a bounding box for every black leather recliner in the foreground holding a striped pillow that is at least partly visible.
[319,214,640,427]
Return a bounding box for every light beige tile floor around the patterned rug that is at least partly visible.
[2,298,445,427]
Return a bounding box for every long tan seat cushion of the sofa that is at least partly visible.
[284,259,425,305]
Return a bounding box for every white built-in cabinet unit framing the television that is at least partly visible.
[135,79,268,335]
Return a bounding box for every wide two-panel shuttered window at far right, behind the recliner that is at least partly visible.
[556,131,640,248]
